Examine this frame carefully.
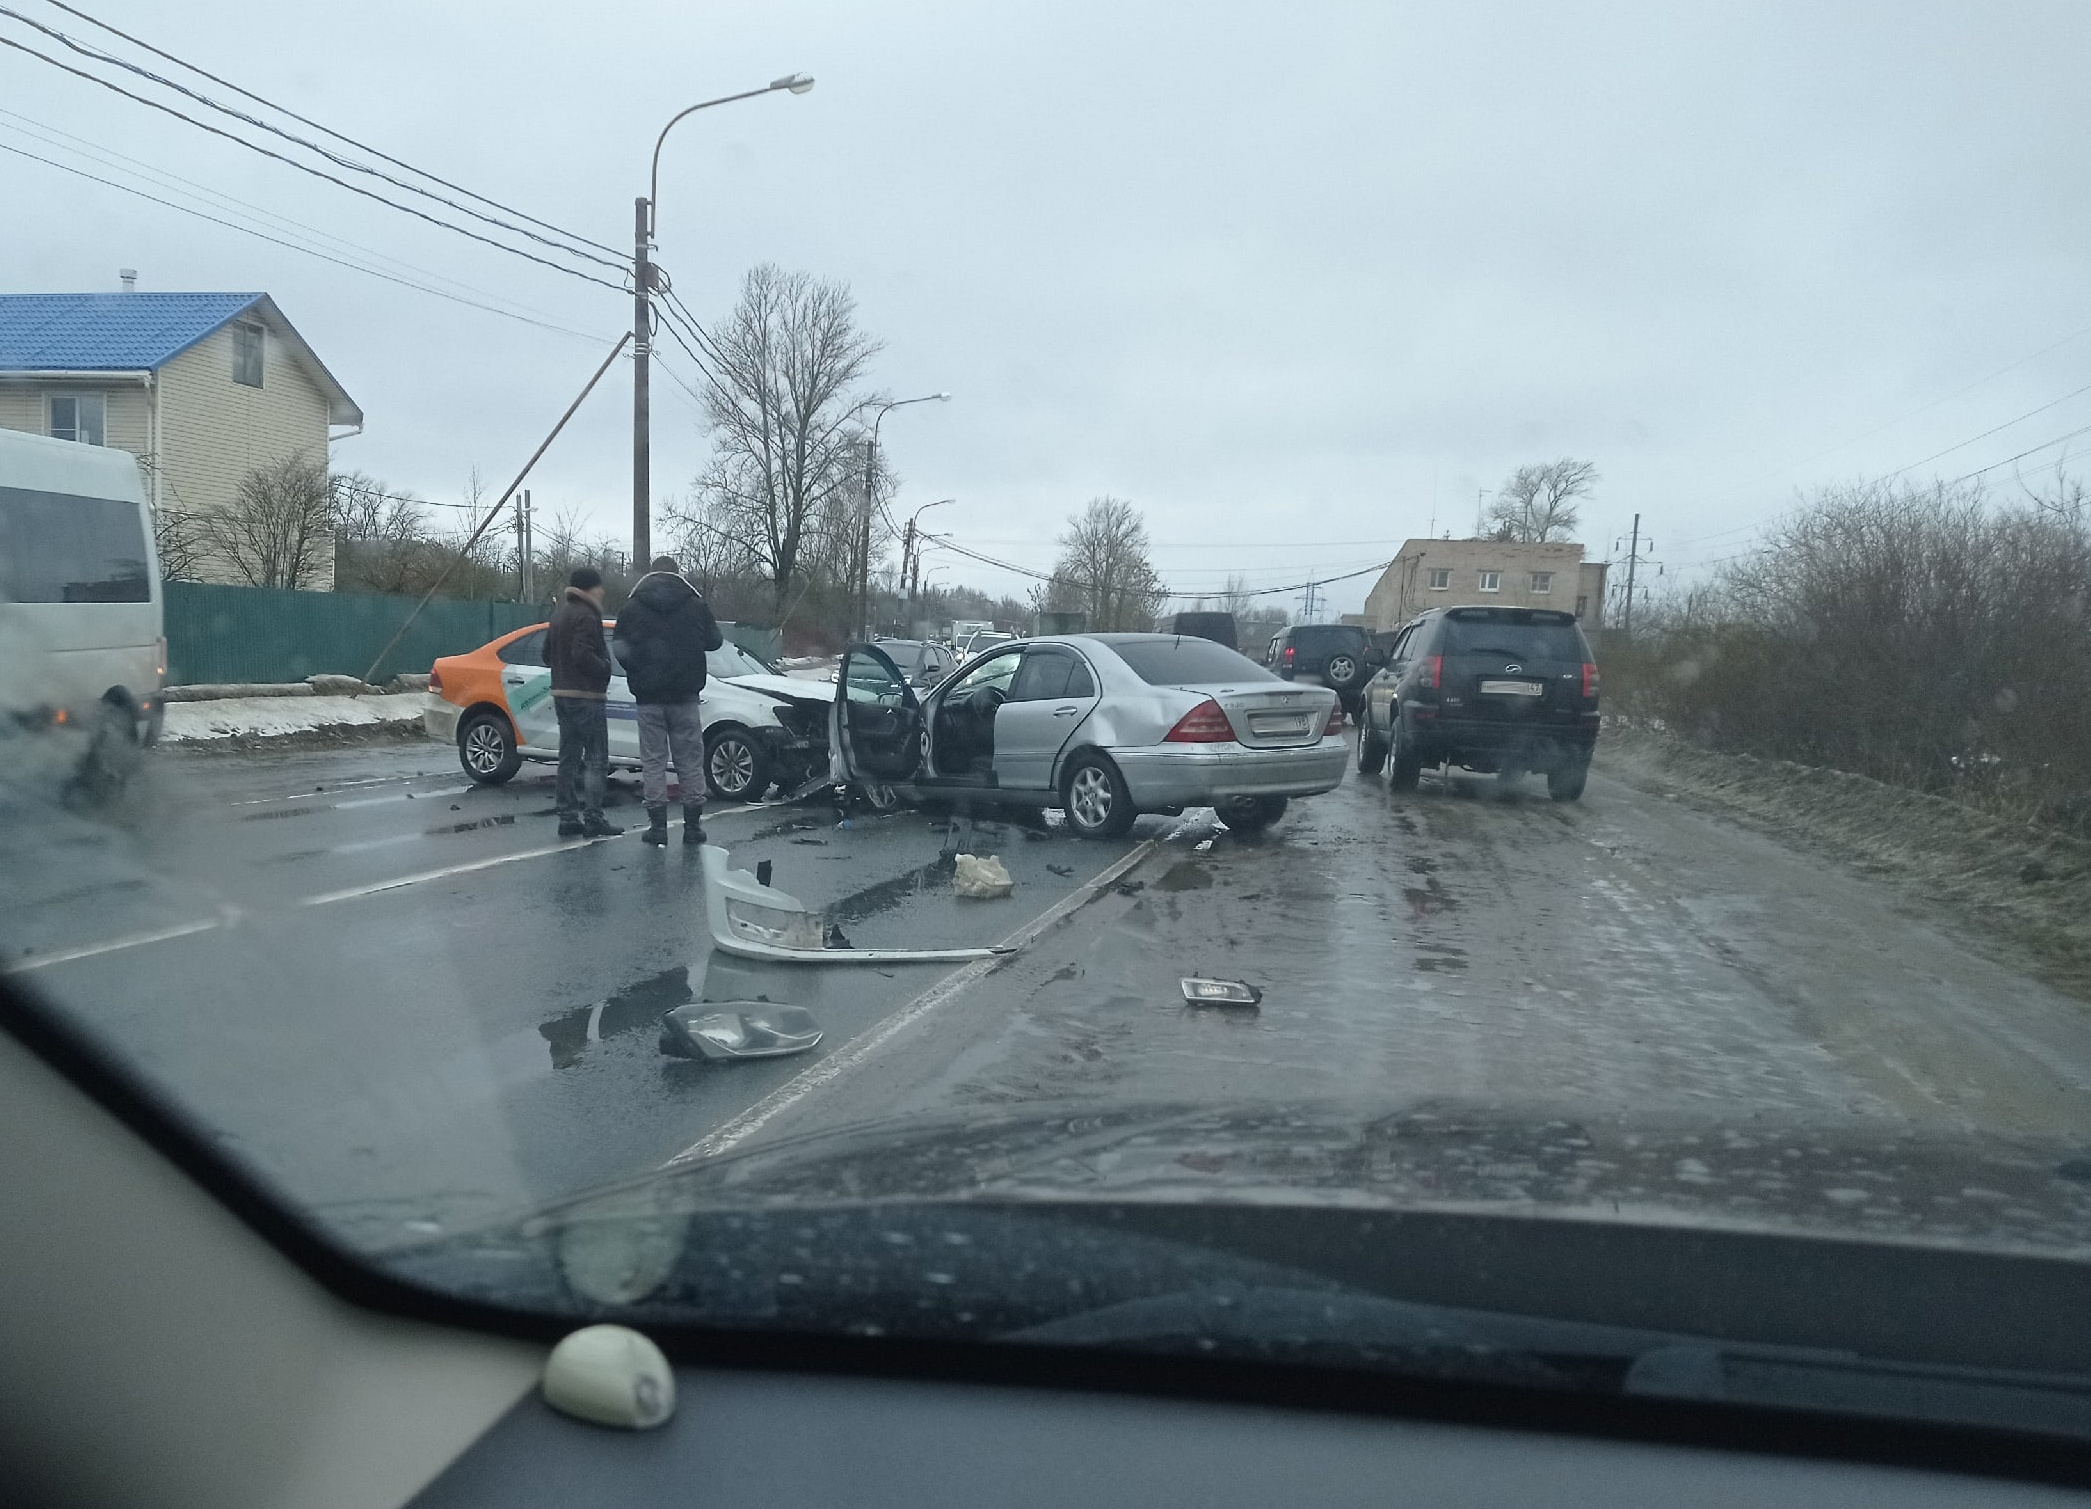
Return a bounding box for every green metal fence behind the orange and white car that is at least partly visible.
[167,581,550,686]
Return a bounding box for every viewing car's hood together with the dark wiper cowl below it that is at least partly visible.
[381,1106,2091,1412]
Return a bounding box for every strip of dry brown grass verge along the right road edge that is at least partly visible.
[1598,725,2091,1001]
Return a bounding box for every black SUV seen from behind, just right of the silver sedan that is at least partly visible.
[1357,608,1598,803]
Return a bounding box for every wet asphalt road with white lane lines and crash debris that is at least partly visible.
[0,744,2091,1246]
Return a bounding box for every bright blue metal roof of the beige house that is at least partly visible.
[0,293,263,372]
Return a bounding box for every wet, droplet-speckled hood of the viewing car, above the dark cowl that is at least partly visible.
[648,1104,2091,1256]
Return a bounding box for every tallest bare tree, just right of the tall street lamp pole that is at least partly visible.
[696,263,880,614]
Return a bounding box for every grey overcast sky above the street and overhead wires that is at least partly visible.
[0,0,2091,610]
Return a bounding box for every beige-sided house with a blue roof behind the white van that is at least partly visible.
[0,280,364,585]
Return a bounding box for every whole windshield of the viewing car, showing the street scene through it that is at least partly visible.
[0,0,2091,1437]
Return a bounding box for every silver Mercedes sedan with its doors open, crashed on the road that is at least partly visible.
[828,633,1347,838]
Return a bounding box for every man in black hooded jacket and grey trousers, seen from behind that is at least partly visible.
[617,556,721,844]
